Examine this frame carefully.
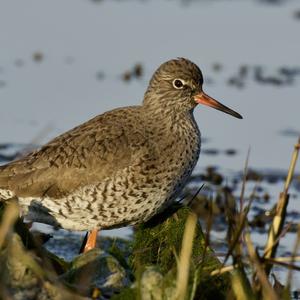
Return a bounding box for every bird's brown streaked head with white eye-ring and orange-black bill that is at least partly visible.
[144,58,242,119]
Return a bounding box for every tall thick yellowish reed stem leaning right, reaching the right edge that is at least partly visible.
[264,138,300,275]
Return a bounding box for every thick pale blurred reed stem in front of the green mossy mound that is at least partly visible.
[175,213,197,300]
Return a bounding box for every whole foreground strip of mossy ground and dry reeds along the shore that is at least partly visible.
[0,139,300,300]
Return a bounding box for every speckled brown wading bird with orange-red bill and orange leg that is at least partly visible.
[0,58,242,252]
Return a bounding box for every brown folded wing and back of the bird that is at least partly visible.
[0,107,146,198]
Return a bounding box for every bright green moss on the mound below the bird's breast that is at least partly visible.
[130,207,230,299]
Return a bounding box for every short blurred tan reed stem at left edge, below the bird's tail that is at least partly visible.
[0,201,19,249]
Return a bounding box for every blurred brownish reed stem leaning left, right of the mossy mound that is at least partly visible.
[245,232,278,300]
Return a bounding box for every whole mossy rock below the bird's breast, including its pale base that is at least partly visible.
[113,207,230,300]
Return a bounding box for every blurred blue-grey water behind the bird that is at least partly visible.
[0,0,300,290]
